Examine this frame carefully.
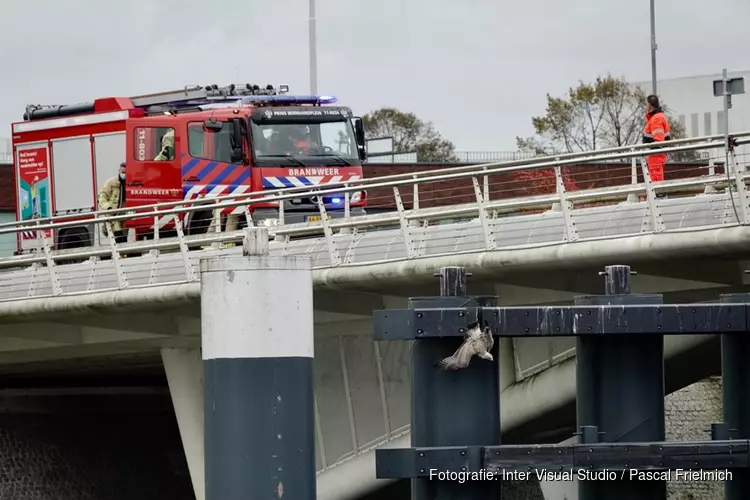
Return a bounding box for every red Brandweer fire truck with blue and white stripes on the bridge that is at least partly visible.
[12,84,367,253]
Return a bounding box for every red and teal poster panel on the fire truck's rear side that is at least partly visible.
[18,147,52,240]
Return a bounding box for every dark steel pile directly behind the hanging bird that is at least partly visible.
[409,267,500,500]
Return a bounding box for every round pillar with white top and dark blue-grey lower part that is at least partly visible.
[201,228,316,500]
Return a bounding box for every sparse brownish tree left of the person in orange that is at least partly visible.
[516,75,698,161]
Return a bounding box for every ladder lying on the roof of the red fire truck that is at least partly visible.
[130,83,289,108]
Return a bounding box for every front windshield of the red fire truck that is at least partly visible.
[251,120,358,164]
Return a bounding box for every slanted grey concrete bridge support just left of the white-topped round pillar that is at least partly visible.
[161,348,206,500]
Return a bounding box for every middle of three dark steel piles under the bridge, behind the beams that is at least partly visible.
[575,265,667,500]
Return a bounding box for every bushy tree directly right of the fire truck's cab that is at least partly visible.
[362,108,458,163]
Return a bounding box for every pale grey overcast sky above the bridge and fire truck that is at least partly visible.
[0,0,750,151]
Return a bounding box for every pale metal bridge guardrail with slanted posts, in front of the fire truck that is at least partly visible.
[0,132,750,268]
